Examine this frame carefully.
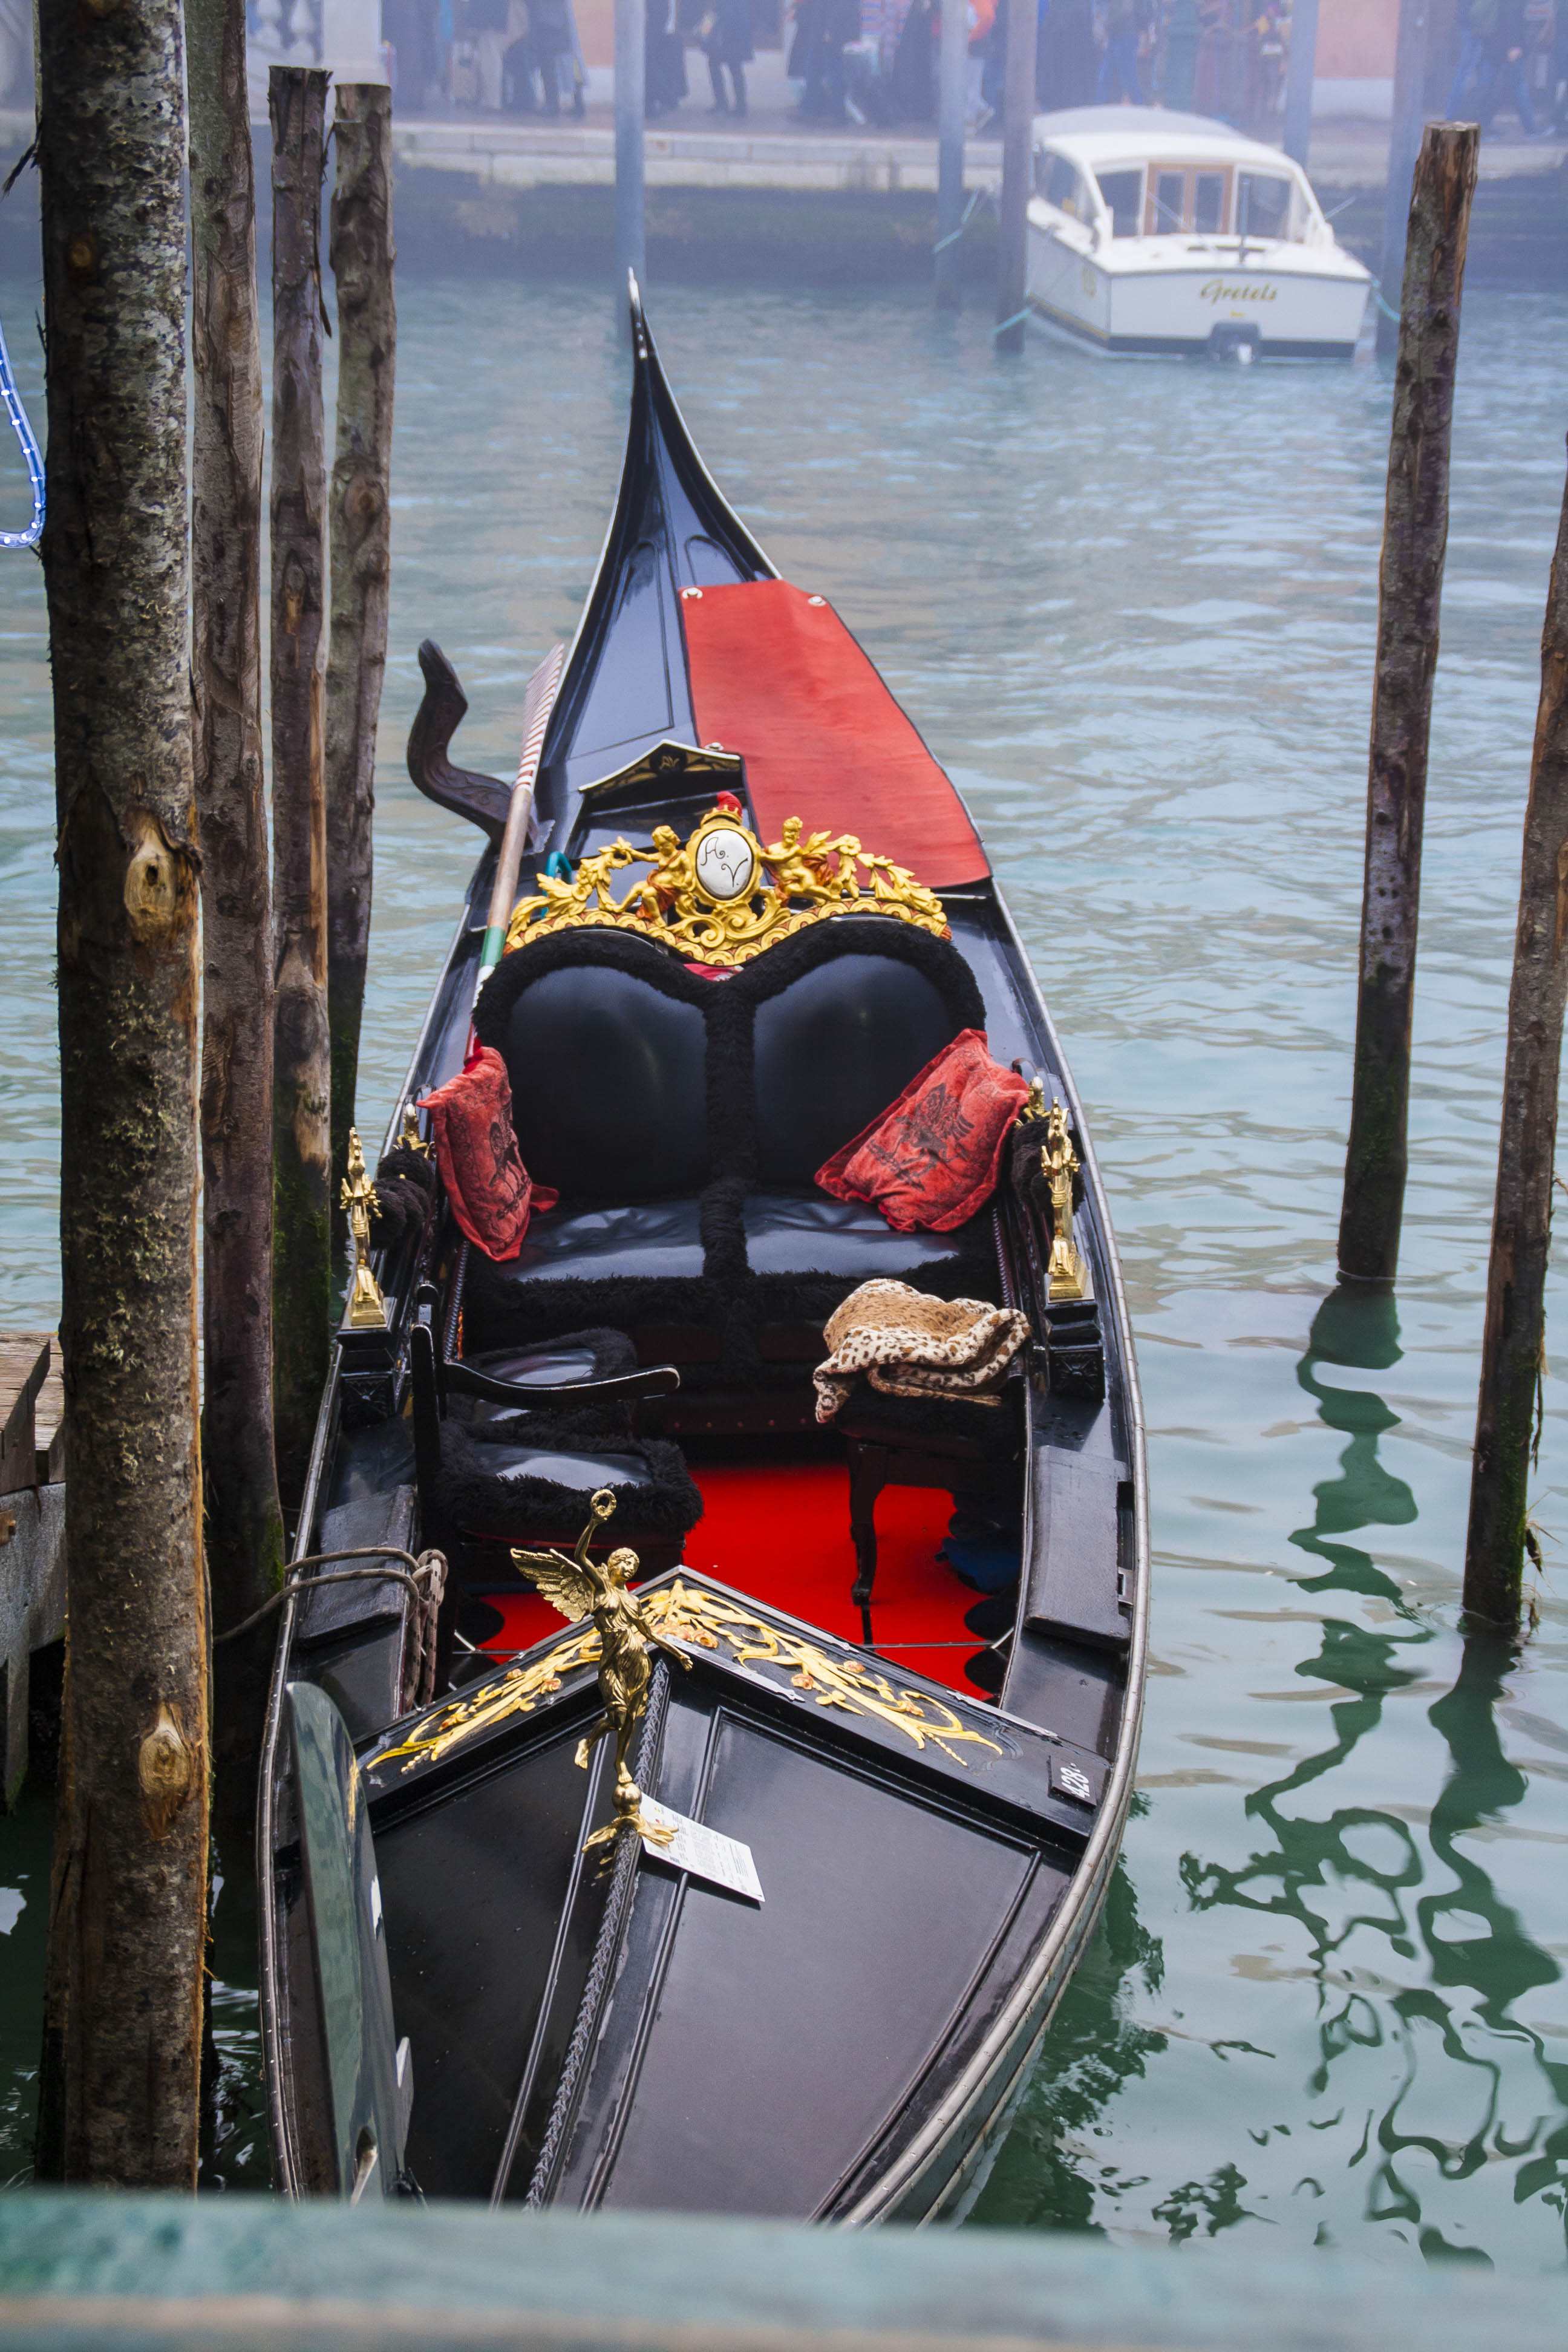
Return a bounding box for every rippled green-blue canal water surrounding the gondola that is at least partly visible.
[0,262,1568,2272]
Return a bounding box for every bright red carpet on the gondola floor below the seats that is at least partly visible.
[485,1460,980,1696]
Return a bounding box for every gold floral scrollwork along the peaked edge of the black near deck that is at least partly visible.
[371,1580,1001,1778]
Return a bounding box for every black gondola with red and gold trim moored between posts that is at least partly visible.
[258,287,1147,2223]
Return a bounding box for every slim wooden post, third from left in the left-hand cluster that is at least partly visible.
[268,66,332,1510]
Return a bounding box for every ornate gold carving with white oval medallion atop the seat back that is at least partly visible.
[506,792,950,964]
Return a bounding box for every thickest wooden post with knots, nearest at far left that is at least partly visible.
[38,0,207,2190]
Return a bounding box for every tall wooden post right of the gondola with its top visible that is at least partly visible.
[1340,122,1481,1282]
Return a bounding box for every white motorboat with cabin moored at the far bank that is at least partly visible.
[1030,106,1373,362]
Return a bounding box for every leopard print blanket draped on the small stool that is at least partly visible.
[814,1282,1030,1420]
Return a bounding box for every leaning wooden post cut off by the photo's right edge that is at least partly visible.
[1465,454,1568,1625]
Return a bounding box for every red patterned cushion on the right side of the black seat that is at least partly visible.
[815,1030,1030,1232]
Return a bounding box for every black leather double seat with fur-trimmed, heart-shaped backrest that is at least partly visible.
[465,915,990,1388]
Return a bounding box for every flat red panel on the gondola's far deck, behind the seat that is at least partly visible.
[682,581,990,889]
